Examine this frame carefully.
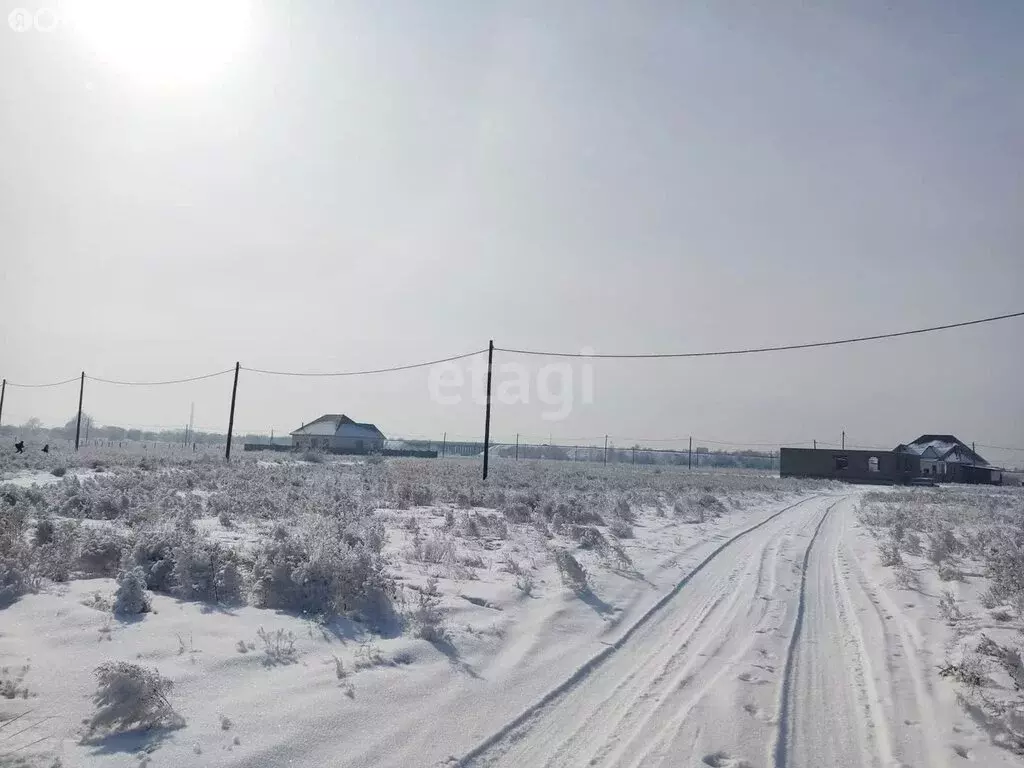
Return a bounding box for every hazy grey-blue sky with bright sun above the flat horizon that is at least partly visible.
[0,0,1024,463]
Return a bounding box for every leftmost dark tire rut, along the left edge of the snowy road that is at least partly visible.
[456,494,822,766]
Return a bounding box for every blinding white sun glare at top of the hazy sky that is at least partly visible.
[68,0,251,84]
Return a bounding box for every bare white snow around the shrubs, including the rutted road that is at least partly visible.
[0,461,1020,768]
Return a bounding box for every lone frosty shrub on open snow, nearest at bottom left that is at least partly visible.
[88,662,183,734]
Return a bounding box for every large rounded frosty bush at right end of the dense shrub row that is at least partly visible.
[252,517,394,614]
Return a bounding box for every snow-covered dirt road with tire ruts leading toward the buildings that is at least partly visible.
[461,494,991,768]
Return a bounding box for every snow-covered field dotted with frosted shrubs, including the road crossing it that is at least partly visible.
[0,451,1024,768]
